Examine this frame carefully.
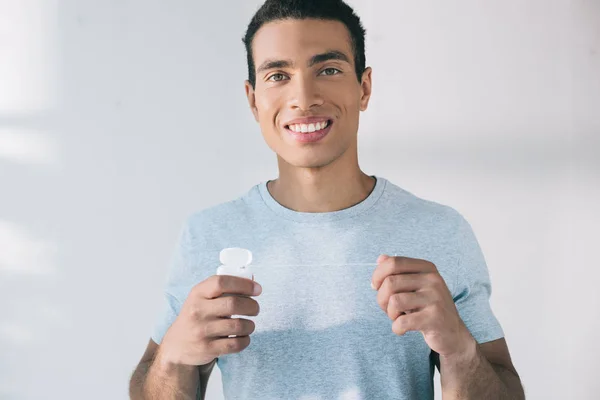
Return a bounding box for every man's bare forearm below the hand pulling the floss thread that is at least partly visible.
[436,339,525,400]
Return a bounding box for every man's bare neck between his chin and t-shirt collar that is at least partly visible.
[267,148,375,213]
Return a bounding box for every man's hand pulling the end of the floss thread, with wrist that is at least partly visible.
[372,255,476,357]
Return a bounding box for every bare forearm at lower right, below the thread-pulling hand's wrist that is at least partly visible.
[440,344,525,400]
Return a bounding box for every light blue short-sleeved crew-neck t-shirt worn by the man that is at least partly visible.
[152,177,504,400]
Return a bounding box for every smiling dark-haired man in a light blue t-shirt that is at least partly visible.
[130,0,524,400]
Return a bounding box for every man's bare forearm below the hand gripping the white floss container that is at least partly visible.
[129,340,215,400]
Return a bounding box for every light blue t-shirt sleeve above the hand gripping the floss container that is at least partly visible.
[151,219,198,344]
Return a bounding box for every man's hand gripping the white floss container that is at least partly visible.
[160,275,262,366]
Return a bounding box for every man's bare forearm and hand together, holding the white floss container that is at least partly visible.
[130,275,262,400]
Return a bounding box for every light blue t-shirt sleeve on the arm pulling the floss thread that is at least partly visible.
[453,212,504,343]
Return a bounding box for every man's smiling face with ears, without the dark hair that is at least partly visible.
[246,19,371,168]
